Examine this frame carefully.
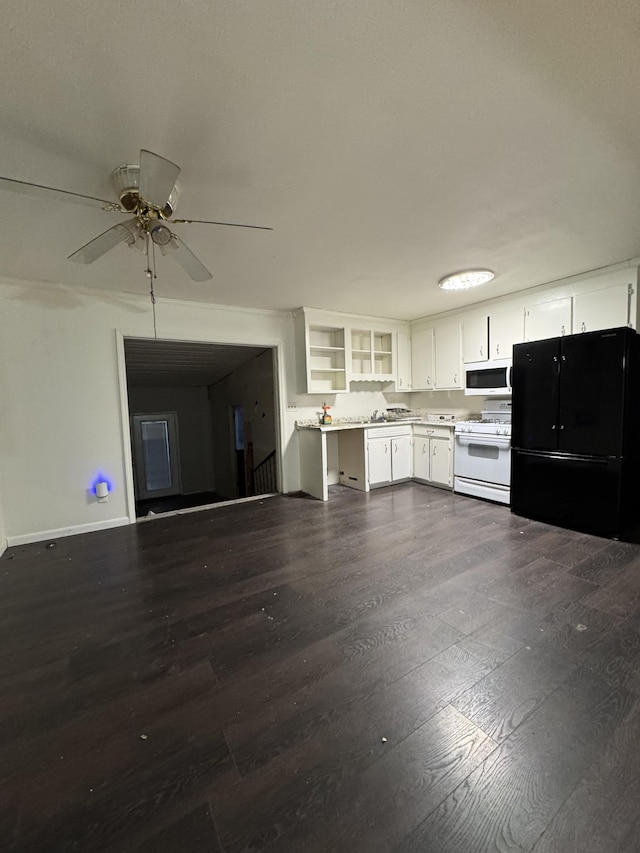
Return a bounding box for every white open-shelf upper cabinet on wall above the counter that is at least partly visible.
[296,308,409,394]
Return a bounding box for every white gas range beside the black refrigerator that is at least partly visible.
[453,399,511,504]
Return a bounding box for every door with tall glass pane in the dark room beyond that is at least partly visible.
[131,412,182,500]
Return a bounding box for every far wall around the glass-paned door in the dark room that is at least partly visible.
[129,385,215,495]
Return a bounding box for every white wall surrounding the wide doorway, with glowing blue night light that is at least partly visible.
[0,281,299,545]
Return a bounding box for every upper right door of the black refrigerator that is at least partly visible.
[558,329,635,456]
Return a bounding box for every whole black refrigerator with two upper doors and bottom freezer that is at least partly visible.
[511,328,640,539]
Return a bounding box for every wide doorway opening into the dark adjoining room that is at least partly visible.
[124,338,279,518]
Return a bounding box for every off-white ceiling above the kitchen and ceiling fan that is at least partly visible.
[0,0,640,319]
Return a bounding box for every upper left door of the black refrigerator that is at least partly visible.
[511,338,560,450]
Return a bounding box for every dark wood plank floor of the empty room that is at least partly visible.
[0,484,640,853]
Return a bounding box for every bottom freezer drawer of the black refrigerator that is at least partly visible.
[511,449,630,536]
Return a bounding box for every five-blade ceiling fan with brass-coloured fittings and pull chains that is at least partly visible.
[0,148,273,281]
